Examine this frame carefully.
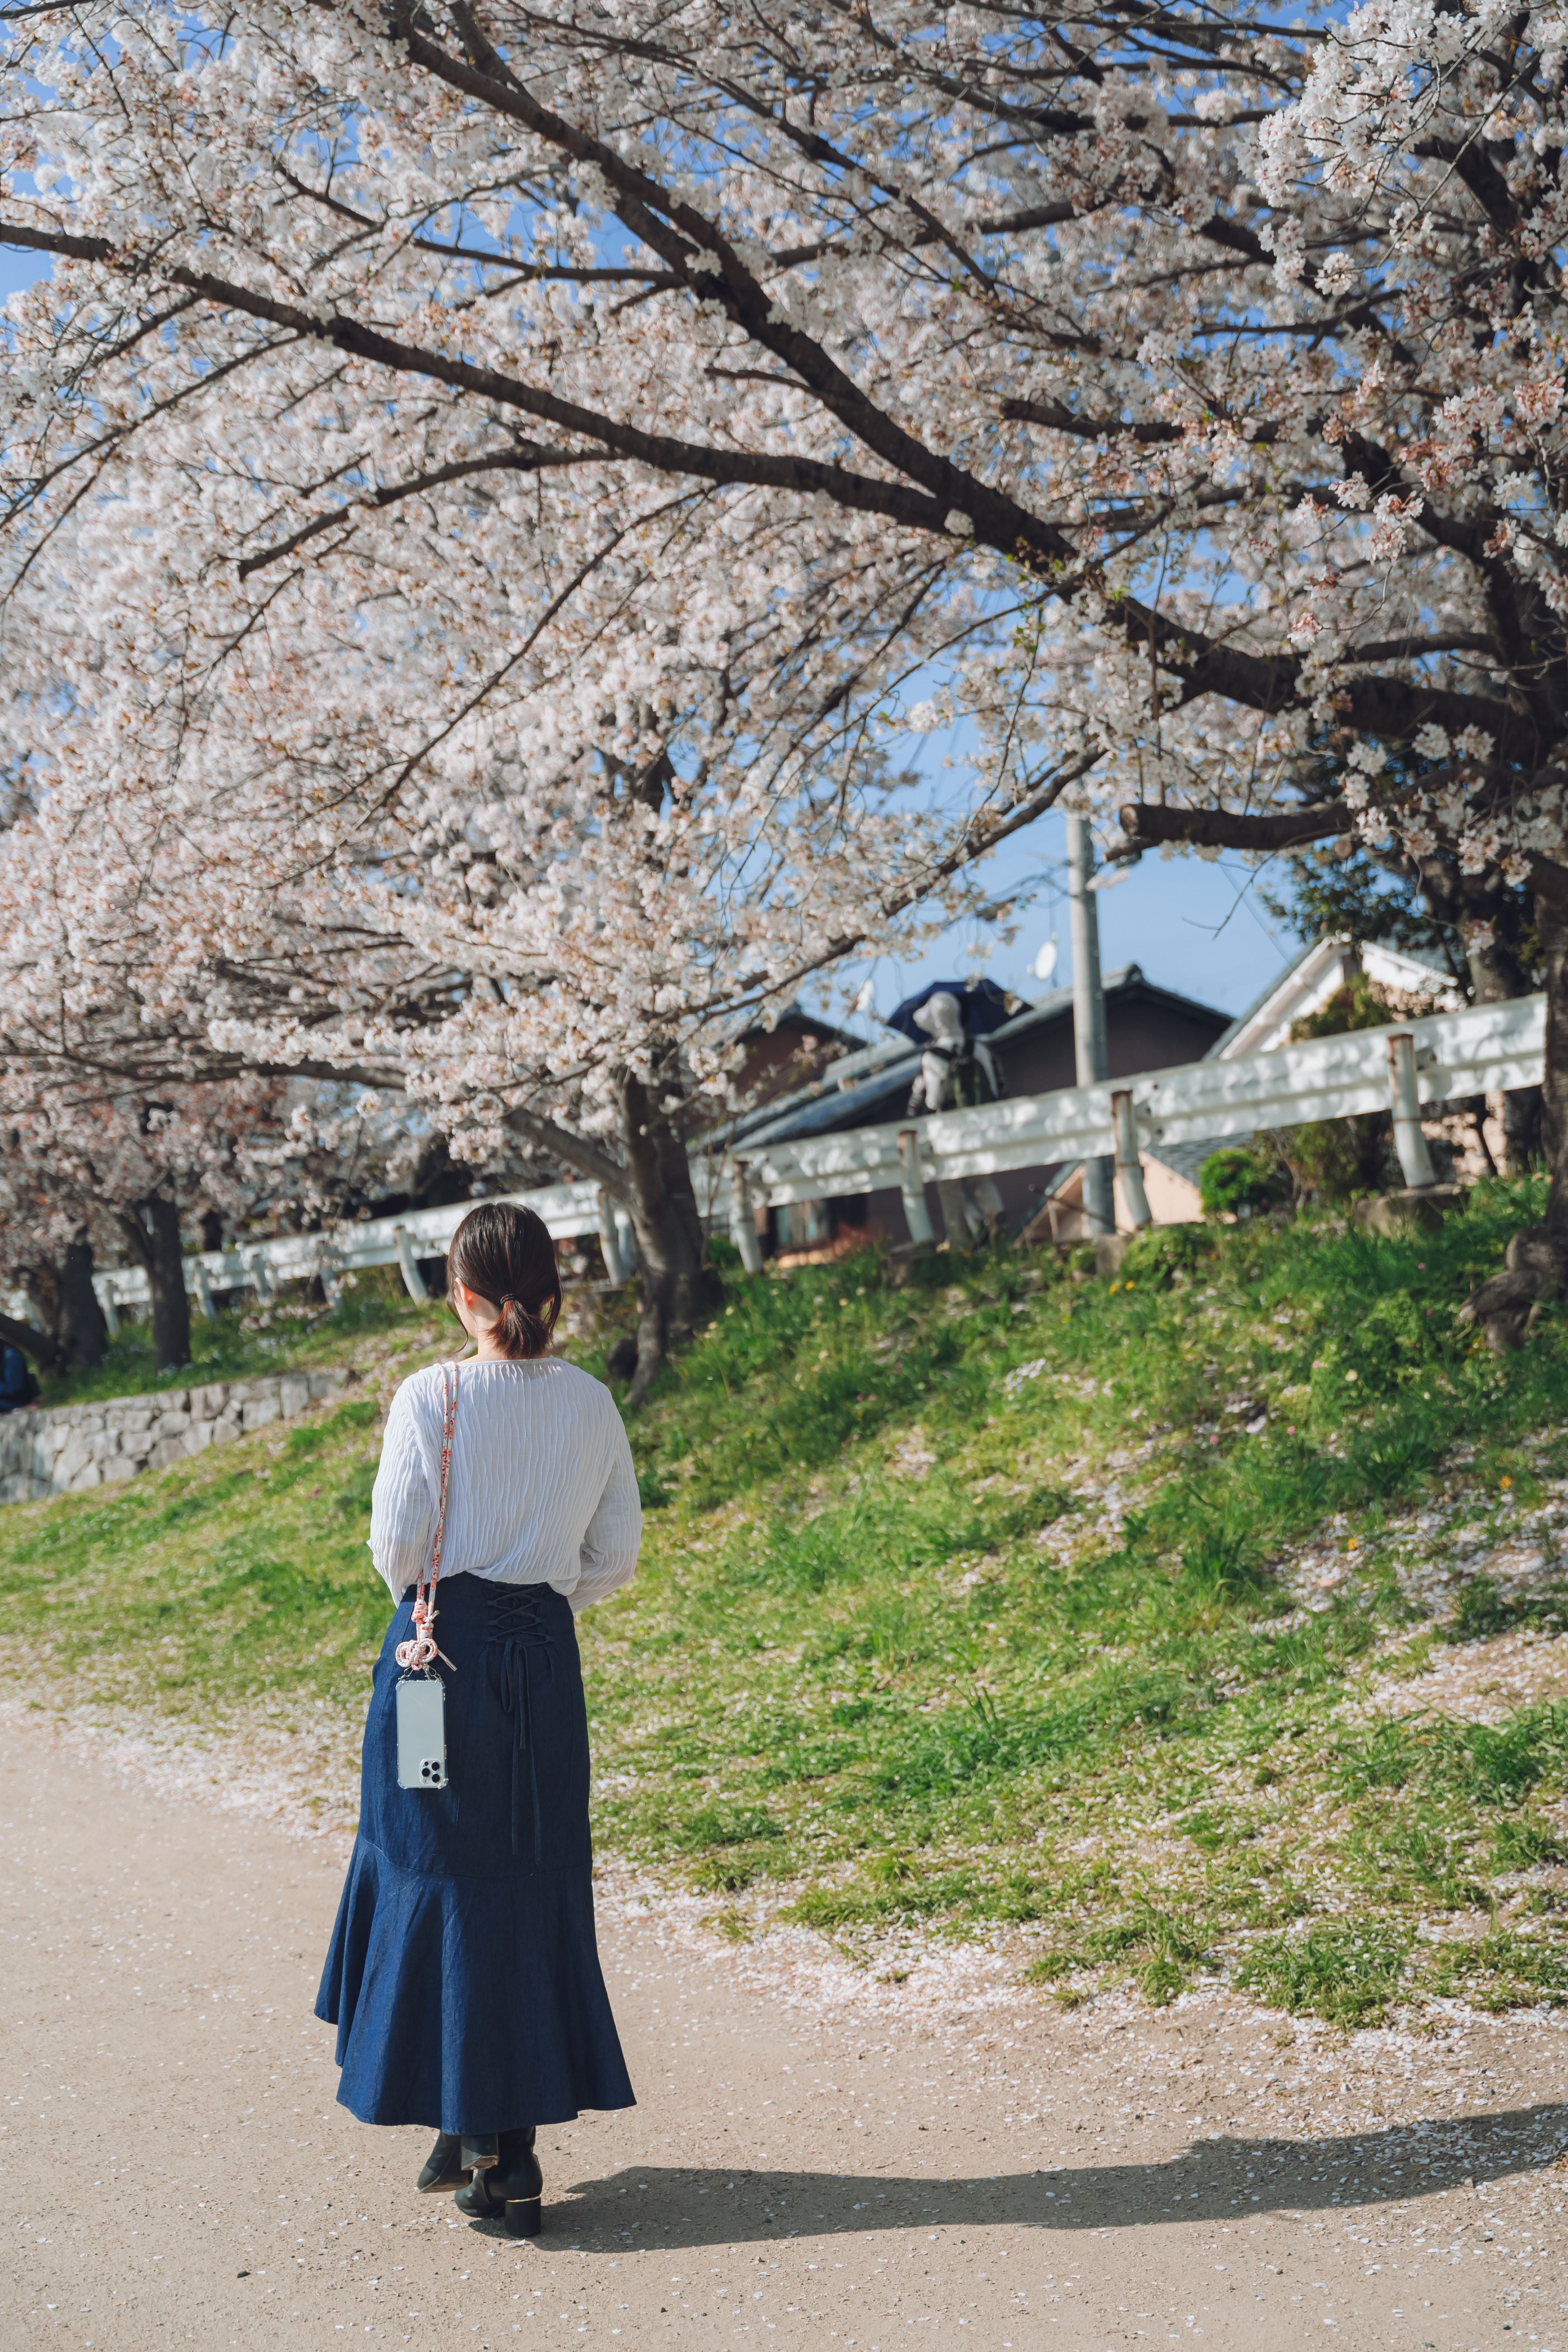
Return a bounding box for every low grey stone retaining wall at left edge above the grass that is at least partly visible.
[0,1371,348,1503]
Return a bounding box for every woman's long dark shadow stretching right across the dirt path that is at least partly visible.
[460,2103,1568,2251]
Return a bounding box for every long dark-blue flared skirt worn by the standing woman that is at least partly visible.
[315,1576,635,2136]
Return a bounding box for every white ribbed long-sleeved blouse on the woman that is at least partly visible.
[369,1355,642,1611]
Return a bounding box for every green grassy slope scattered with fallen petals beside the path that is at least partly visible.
[0,1188,1568,2023]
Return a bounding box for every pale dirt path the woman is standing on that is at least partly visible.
[0,1710,1568,2352]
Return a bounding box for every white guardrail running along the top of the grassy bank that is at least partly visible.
[80,995,1547,1315]
